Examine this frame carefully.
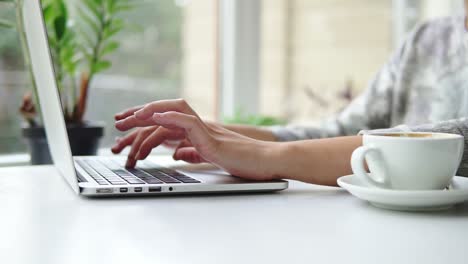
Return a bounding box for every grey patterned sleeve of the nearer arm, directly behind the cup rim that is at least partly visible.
[359,118,468,177]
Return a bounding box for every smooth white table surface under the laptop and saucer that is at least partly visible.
[0,161,468,264]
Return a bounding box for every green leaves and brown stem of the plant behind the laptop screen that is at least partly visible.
[0,0,135,124]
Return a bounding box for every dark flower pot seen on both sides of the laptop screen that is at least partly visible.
[22,123,104,165]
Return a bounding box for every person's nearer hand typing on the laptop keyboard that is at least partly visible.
[112,99,278,180]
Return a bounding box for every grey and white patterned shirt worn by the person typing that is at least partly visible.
[272,16,468,176]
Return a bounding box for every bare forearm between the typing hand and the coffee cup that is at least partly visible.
[270,136,362,186]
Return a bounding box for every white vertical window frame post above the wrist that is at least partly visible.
[218,0,261,117]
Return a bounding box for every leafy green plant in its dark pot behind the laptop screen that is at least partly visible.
[0,0,134,164]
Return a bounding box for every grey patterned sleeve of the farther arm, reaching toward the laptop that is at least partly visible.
[271,24,413,141]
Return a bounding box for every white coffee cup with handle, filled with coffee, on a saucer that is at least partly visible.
[351,132,464,190]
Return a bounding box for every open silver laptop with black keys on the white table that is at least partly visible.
[22,0,288,197]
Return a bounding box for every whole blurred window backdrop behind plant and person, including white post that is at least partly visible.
[0,0,463,155]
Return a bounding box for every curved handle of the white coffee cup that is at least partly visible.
[351,146,389,188]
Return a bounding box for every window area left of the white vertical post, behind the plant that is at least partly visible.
[0,0,217,154]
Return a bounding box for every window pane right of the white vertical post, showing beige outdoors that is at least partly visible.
[258,0,463,123]
